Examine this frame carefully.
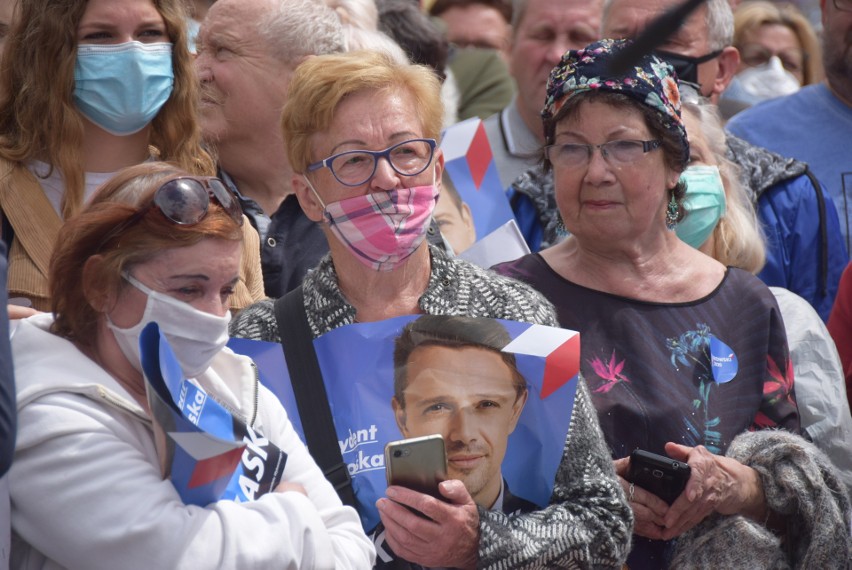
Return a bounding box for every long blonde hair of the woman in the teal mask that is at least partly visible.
[683,99,766,273]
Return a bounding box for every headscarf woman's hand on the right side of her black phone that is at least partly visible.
[662,442,767,540]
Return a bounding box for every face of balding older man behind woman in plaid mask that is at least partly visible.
[195,0,292,153]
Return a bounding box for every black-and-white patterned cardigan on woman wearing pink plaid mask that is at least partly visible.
[231,246,633,569]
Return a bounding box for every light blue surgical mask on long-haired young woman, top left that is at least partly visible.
[74,42,175,136]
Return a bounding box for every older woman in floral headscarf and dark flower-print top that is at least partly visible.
[498,40,850,568]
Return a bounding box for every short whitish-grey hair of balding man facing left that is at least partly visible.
[257,0,346,63]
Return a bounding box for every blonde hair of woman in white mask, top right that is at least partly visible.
[734,0,825,85]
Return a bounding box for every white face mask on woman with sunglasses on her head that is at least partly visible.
[107,273,231,378]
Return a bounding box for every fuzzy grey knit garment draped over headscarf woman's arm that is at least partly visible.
[671,430,852,570]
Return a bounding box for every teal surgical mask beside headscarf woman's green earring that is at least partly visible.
[675,165,725,249]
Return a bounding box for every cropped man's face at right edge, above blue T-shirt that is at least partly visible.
[820,0,852,97]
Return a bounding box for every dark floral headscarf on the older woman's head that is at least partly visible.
[541,39,689,167]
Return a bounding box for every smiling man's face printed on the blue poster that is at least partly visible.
[393,345,527,508]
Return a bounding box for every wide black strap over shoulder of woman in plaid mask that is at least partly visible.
[275,285,355,507]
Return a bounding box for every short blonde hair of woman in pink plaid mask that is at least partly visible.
[281,51,444,173]
